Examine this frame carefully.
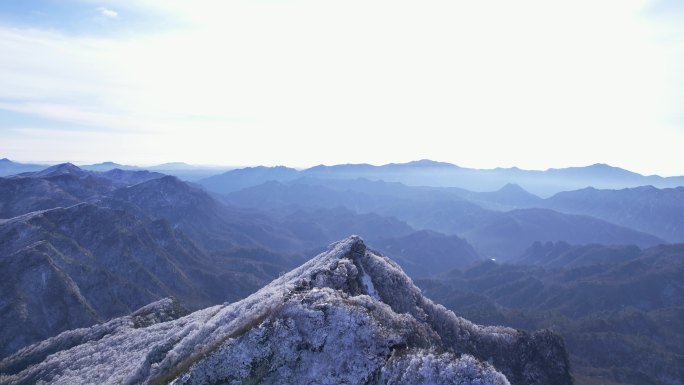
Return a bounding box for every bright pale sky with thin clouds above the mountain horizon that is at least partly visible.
[0,0,684,176]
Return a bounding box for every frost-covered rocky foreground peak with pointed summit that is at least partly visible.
[0,237,572,385]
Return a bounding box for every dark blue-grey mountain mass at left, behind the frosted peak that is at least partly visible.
[0,163,475,357]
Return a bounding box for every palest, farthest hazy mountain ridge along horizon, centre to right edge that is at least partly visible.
[198,160,684,196]
